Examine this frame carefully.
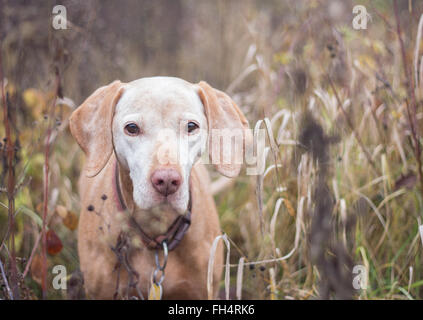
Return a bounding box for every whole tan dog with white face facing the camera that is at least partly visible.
[70,77,252,299]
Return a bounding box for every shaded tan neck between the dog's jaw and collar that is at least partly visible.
[115,165,183,237]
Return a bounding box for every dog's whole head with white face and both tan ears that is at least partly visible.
[70,77,249,213]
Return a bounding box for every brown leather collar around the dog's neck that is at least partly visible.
[114,161,192,251]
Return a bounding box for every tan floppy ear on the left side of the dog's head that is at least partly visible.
[69,80,123,177]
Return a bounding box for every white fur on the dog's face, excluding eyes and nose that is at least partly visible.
[112,77,207,214]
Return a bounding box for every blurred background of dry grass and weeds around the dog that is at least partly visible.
[0,0,423,299]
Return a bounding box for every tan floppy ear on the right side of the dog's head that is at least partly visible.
[198,81,252,177]
